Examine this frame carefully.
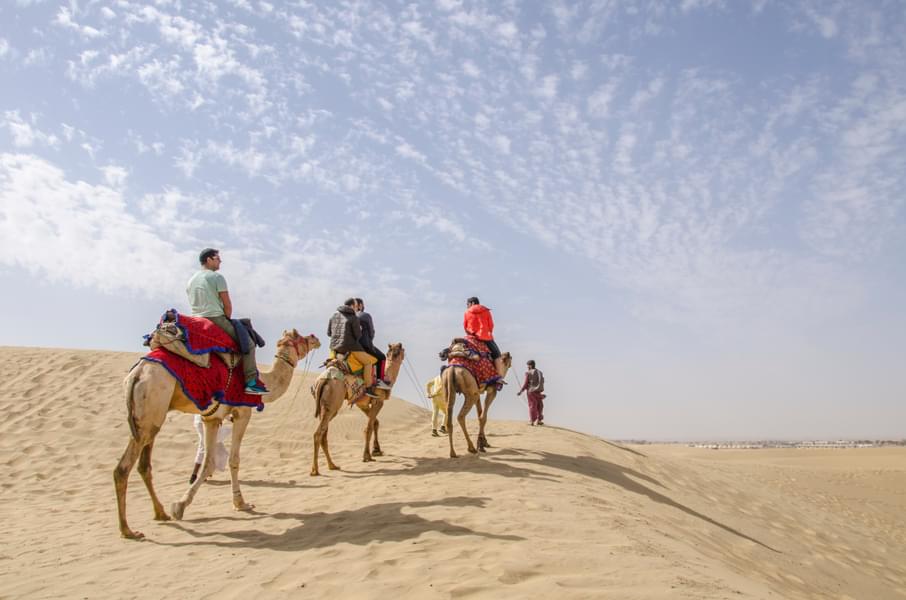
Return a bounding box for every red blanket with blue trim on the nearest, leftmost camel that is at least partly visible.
[141,311,264,411]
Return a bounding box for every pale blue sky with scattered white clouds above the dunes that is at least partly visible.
[0,0,906,440]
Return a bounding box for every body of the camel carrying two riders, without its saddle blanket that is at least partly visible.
[311,342,406,477]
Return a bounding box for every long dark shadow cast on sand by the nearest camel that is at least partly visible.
[152,496,525,552]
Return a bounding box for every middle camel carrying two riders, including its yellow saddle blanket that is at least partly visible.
[311,342,406,476]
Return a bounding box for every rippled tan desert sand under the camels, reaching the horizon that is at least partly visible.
[0,347,906,600]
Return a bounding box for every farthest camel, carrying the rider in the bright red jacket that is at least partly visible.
[441,352,513,458]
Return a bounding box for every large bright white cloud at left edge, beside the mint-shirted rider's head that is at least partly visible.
[0,154,182,294]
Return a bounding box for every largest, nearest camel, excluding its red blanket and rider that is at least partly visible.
[113,329,321,539]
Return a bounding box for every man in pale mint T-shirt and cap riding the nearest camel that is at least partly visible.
[186,248,268,396]
